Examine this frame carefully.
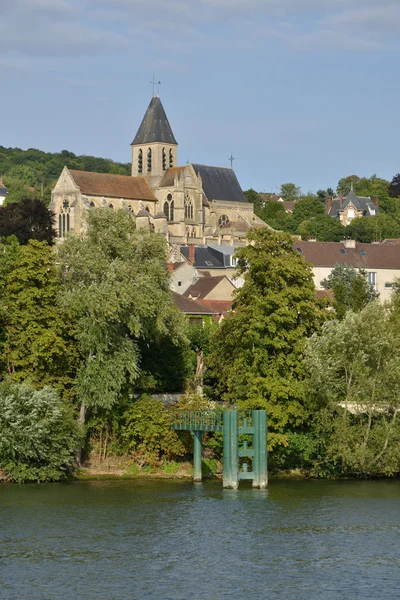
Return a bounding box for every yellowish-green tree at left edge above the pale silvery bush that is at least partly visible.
[2,240,76,390]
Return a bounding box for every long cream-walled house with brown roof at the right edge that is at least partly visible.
[293,240,400,302]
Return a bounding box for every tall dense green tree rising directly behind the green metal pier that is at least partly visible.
[209,229,324,447]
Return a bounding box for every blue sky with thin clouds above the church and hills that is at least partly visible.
[0,0,400,193]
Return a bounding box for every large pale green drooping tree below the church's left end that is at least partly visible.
[57,209,186,440]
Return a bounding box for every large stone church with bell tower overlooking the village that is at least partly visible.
[50,95,266,246]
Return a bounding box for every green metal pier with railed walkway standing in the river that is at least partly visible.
[172,410,268,489]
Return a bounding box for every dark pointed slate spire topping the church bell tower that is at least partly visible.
[132,96,178,146]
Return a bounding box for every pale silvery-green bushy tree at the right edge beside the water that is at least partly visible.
[307,302,400,476]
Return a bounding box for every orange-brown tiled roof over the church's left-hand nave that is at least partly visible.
[69,170,155,200]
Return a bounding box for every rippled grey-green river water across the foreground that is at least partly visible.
[0,480,400,600]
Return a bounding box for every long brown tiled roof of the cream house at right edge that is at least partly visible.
[293,241,400,269]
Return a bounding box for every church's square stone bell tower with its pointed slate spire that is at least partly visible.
[131,95,178,190]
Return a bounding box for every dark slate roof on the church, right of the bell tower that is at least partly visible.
[192,163,247,202]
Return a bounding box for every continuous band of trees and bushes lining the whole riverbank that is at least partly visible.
[0,209,400,482]
